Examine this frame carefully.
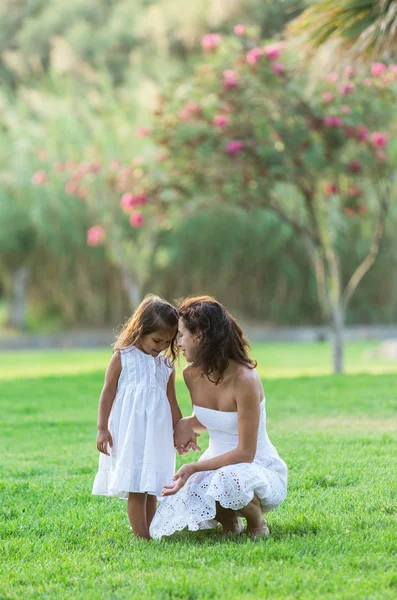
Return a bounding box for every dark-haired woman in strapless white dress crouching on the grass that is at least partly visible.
[150,296,287,538]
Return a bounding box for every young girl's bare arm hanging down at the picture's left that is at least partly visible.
[96,351,121,456]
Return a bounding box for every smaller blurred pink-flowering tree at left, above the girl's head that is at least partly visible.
[31,145,180,310]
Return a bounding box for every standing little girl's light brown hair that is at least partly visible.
[113,294,178,363]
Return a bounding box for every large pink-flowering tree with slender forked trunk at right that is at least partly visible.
[136,32,397,372]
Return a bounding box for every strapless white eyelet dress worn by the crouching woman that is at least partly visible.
[150,400,288,539]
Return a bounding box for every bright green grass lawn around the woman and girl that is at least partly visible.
[0,344,397,600]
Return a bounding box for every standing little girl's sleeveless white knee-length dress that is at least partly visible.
[92,346,175,499]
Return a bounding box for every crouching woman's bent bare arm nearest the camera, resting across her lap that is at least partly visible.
[163,374,262,496]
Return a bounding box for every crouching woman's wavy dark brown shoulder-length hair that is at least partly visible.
[179,296,257,384]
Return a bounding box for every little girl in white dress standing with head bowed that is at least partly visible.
[92,295,193,539]
